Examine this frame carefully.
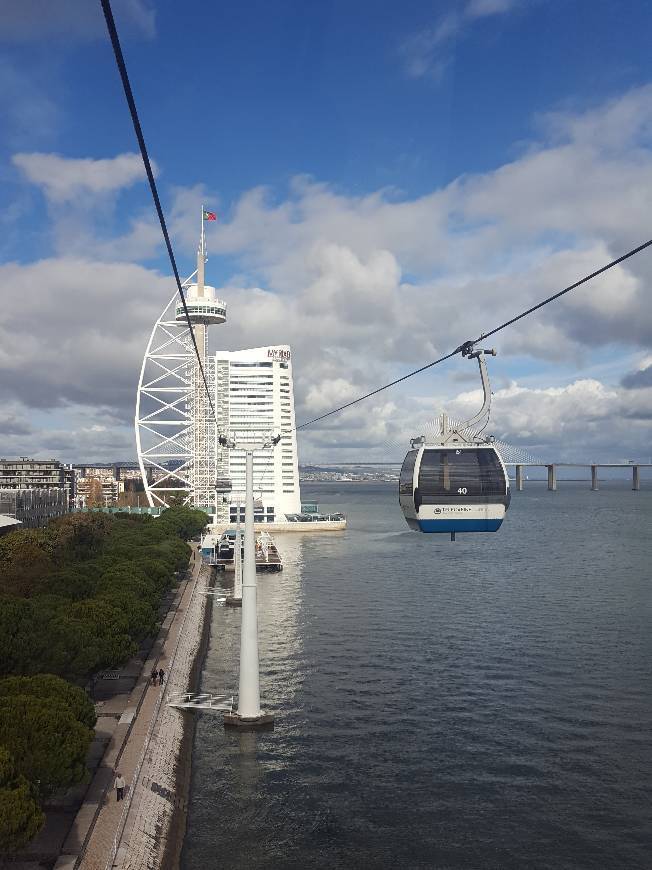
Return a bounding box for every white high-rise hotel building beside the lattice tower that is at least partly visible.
[214,345,301,522]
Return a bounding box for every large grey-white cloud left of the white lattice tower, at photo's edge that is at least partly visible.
[0,258,173,414]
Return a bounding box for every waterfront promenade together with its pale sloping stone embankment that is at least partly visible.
[55,549,207,870]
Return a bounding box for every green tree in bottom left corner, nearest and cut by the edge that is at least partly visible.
[0,746,45,852]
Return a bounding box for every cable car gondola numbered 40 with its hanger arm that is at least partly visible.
[399,350,510,541]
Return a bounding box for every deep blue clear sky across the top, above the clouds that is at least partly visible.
[3,0,652,254]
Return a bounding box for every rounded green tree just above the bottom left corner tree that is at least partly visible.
[0,695,93,796]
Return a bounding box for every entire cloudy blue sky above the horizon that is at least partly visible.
[0,0,652,463]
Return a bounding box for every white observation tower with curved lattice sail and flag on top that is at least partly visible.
[135,207,230,521]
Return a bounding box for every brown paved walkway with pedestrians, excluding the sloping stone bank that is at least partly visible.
[55,550,206,870]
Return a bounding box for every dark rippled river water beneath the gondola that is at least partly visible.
[183,481,652,870]
